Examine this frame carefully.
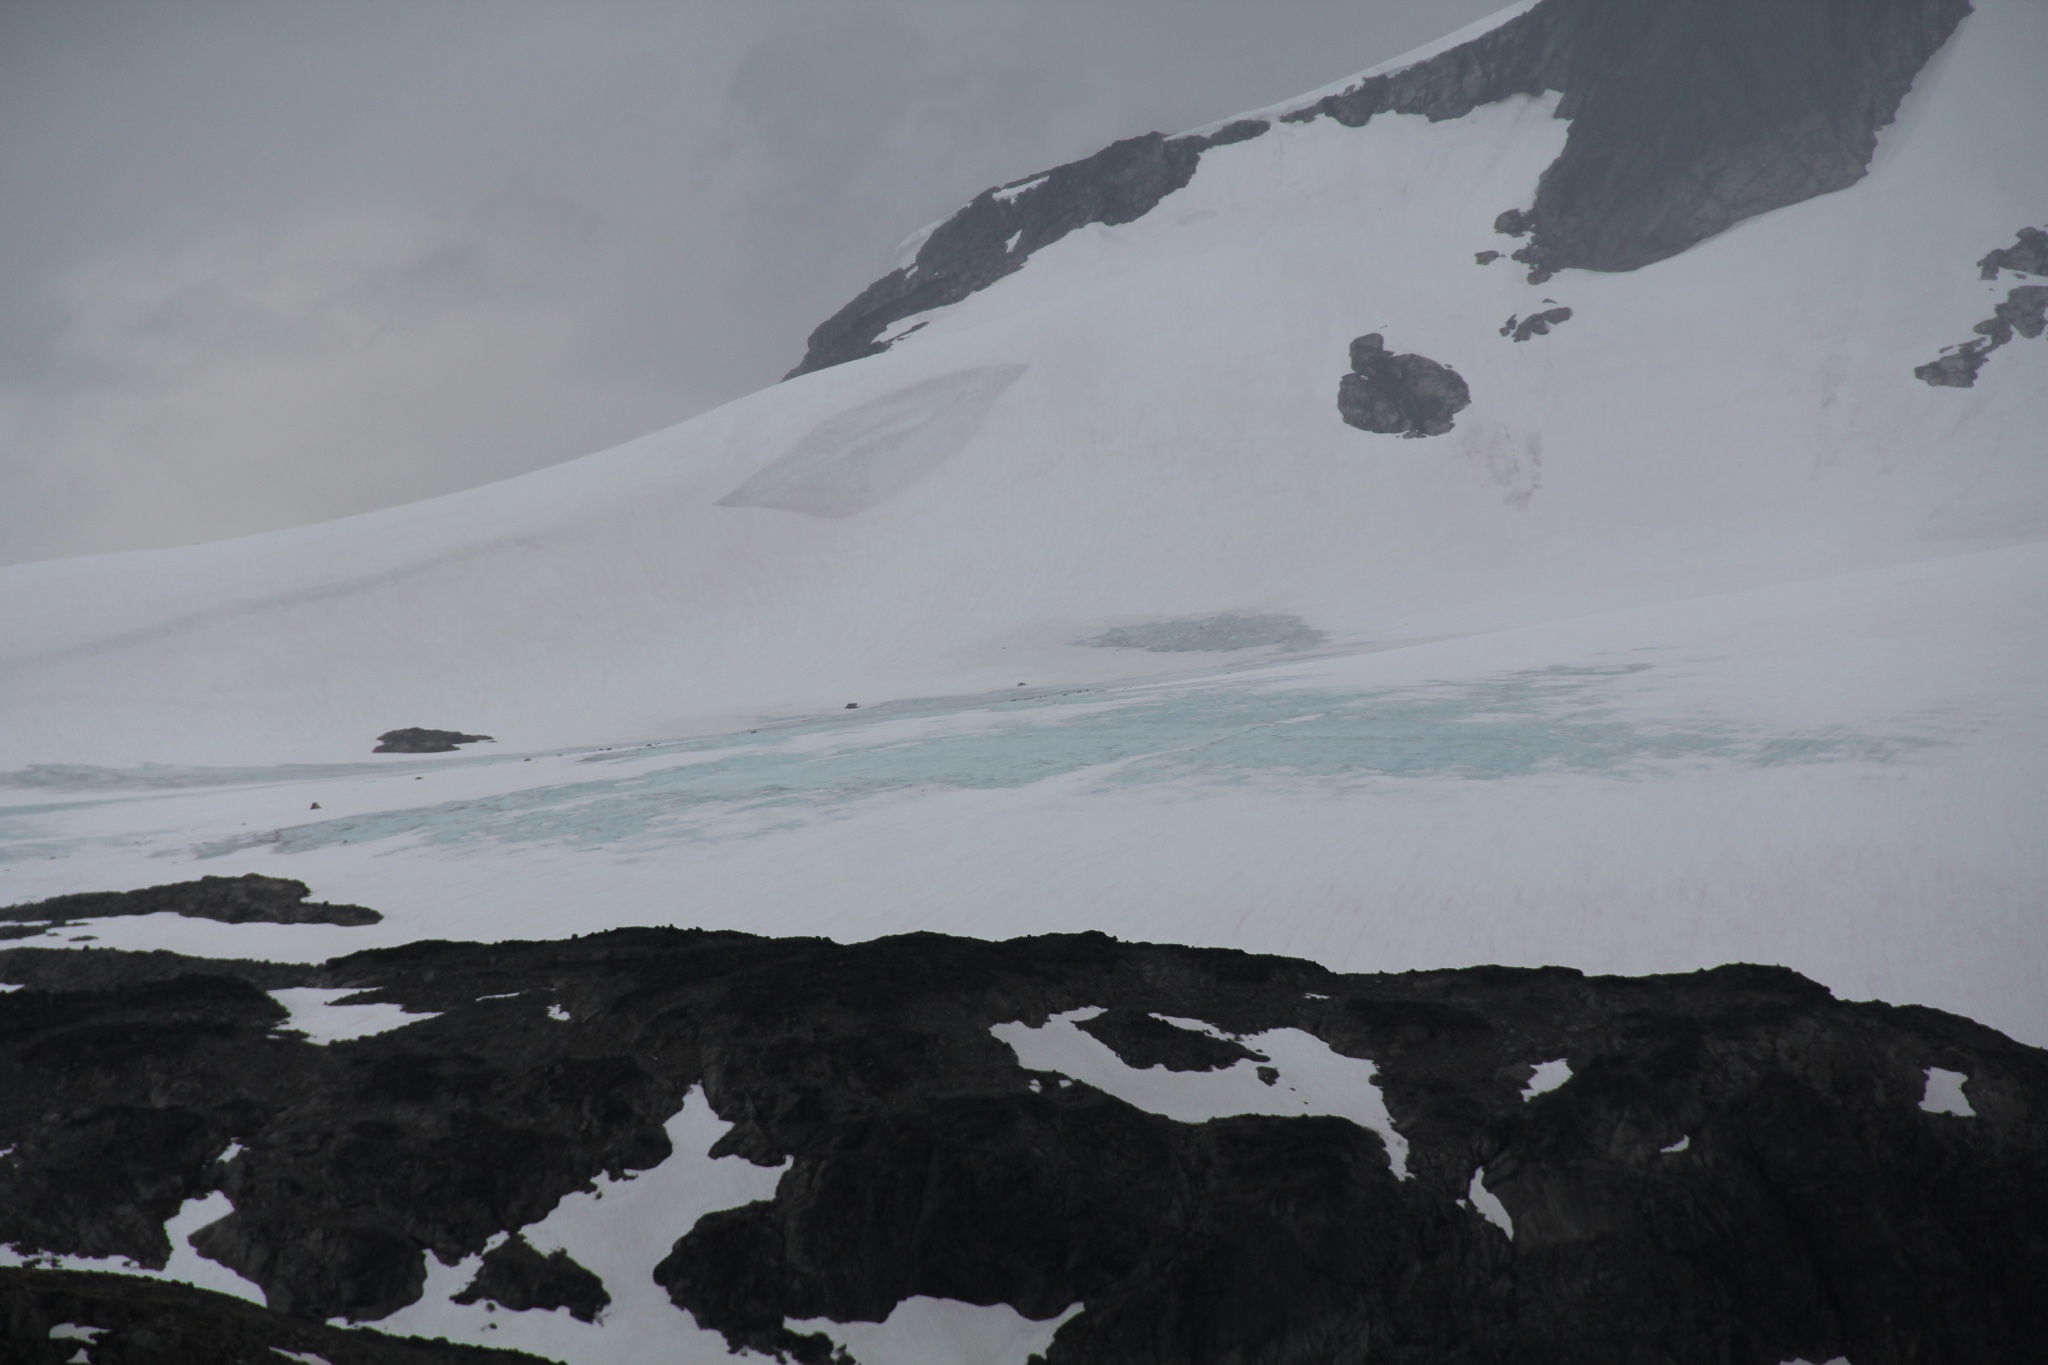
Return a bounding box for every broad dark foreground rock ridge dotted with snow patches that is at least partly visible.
[0,929,2048,1365]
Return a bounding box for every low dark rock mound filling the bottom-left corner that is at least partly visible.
[0,1269,541,1365]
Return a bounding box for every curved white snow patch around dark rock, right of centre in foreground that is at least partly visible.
[989,1009,1409,1181]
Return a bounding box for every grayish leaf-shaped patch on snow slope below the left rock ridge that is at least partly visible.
[719,364,1030,518]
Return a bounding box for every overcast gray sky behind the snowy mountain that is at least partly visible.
[0,0,1501,563]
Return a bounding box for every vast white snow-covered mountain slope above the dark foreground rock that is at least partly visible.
[0,0,2048,1040]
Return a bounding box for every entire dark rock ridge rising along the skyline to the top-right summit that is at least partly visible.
[791,0,1970,375]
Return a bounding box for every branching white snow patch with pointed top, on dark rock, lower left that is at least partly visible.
[377,1087,784,1365]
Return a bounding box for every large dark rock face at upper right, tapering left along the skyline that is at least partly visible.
[1433,0,1970,280]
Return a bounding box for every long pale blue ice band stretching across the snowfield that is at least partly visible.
[148,663,1935,853]
